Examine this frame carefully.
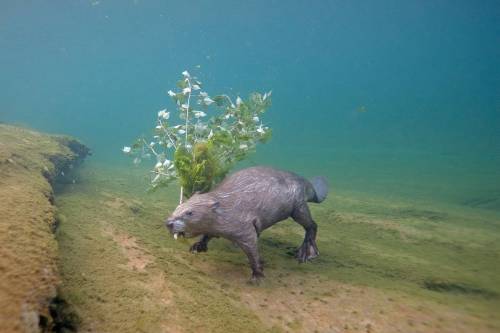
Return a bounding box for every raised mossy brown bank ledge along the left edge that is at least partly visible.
[0,124,89,332]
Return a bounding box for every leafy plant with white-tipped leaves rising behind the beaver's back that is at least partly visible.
[123,71,272,203]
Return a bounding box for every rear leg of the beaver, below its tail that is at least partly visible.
[292,202,319,262]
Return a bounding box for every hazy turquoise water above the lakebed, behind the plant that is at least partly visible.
[0,0,500,211]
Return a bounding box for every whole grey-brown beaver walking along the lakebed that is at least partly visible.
[165,166,328,282]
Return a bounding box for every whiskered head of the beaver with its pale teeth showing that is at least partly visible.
[165,194,219,239]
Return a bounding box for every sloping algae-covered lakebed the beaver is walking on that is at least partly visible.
[56,163,500,332]
